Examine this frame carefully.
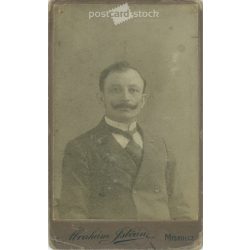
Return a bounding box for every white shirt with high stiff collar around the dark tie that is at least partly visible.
[105,116,143,148]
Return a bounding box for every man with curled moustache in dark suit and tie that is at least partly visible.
[59,62,189,220]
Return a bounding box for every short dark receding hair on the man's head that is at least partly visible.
[99,61,147,92]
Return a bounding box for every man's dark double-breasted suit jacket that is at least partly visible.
[59,120,191,220]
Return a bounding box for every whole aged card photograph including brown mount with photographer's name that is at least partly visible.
[49,0,202,249]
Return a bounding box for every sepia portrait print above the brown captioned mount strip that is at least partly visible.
[52,1,200,221]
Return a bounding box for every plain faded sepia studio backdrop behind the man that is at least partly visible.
[51,4,200,219]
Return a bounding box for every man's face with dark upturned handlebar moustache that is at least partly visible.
[101,69,145,123]
